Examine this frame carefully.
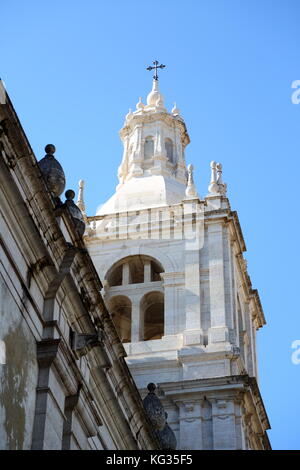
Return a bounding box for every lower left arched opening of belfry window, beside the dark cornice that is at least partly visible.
[108,295,131,343]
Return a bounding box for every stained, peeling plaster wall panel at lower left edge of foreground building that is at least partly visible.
[0,276,38,450]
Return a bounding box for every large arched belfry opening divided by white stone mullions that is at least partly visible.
[103,254,164,343]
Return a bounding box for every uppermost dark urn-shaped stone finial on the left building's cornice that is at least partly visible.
[38,144,66,197]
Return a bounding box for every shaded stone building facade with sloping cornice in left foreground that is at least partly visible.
[0,93,158,450]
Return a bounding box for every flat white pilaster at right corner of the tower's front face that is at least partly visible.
[208,223,229,343]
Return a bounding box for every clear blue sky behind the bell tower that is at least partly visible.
[0,0,300,449]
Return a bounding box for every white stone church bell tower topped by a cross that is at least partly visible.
[83,61,270,450]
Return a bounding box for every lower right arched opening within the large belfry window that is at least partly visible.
[141,292,164,341]
